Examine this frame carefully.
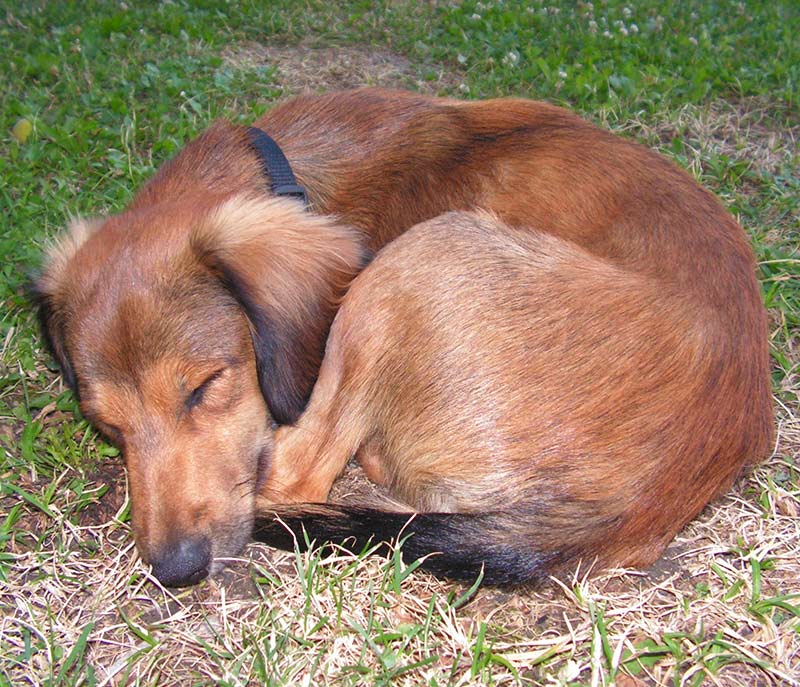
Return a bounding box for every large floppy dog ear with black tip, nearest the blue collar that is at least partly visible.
[191,196,366,424]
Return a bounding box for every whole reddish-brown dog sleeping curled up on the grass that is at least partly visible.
[38,89,772,585]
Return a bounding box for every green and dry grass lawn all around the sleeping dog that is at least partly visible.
[0,0,800,686]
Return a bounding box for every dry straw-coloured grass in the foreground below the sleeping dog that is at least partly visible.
[0,412,800,685]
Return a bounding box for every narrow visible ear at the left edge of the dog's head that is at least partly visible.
[31,217,104,395]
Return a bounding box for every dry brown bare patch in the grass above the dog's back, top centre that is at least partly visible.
[222,42,459,95]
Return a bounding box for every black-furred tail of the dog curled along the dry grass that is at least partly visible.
[253,503,604,586]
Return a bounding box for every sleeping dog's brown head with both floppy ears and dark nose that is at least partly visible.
[37,196,363,585]
